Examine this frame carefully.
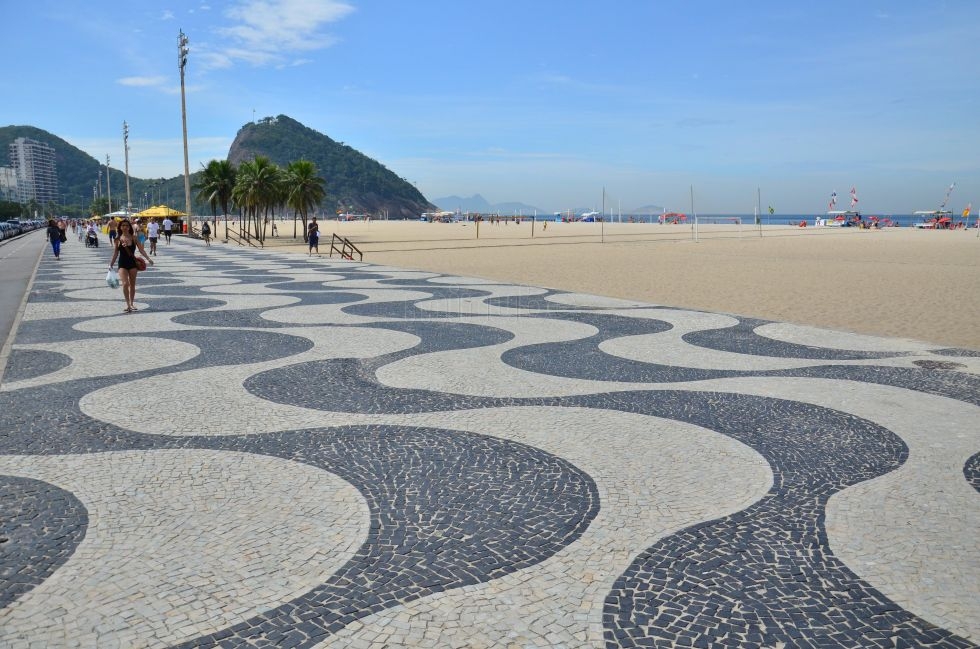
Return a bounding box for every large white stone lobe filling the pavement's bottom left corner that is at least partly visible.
[0,450,369,647]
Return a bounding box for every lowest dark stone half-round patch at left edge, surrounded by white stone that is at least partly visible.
[0,475,88,609]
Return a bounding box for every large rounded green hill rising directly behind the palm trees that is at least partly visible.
[228,115,436,219]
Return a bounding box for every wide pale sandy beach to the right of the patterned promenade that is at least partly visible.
[209,221,980,350]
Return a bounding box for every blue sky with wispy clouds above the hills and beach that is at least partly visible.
[0,0,980,214]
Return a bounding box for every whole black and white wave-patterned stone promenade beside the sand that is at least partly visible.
[0,240,980,649]
